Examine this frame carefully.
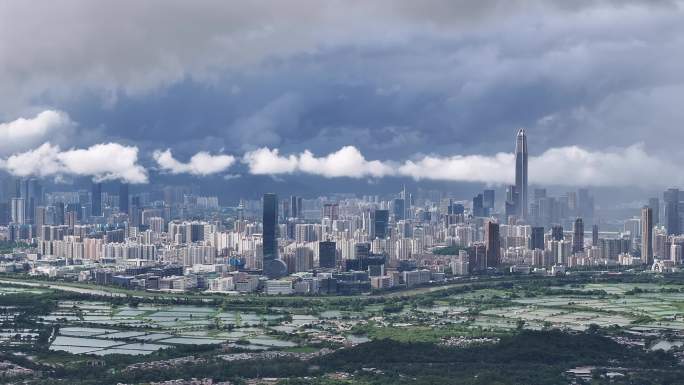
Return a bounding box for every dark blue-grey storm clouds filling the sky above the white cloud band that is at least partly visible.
[0,0,684,174]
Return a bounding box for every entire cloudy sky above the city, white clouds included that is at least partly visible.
[0,0,684,195]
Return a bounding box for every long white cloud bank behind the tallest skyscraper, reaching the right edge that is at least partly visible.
[243,144,684,187]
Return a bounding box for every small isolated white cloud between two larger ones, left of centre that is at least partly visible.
[152,149,235,176]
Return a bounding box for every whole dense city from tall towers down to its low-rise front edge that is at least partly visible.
[0,129,684,294]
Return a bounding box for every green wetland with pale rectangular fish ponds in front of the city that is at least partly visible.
[0,274,684,384]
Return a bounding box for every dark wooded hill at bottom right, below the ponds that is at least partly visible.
[319,330,684,384]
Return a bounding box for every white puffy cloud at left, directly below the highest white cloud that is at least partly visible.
[0,143,147,183]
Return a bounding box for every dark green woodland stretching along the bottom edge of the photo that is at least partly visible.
[25,330,684,385]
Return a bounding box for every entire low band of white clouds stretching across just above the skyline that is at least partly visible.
[0,143,684,188]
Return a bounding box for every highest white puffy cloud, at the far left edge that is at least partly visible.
[0,110,76,154]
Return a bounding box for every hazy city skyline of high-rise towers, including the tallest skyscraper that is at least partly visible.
[0,129,684,284]
